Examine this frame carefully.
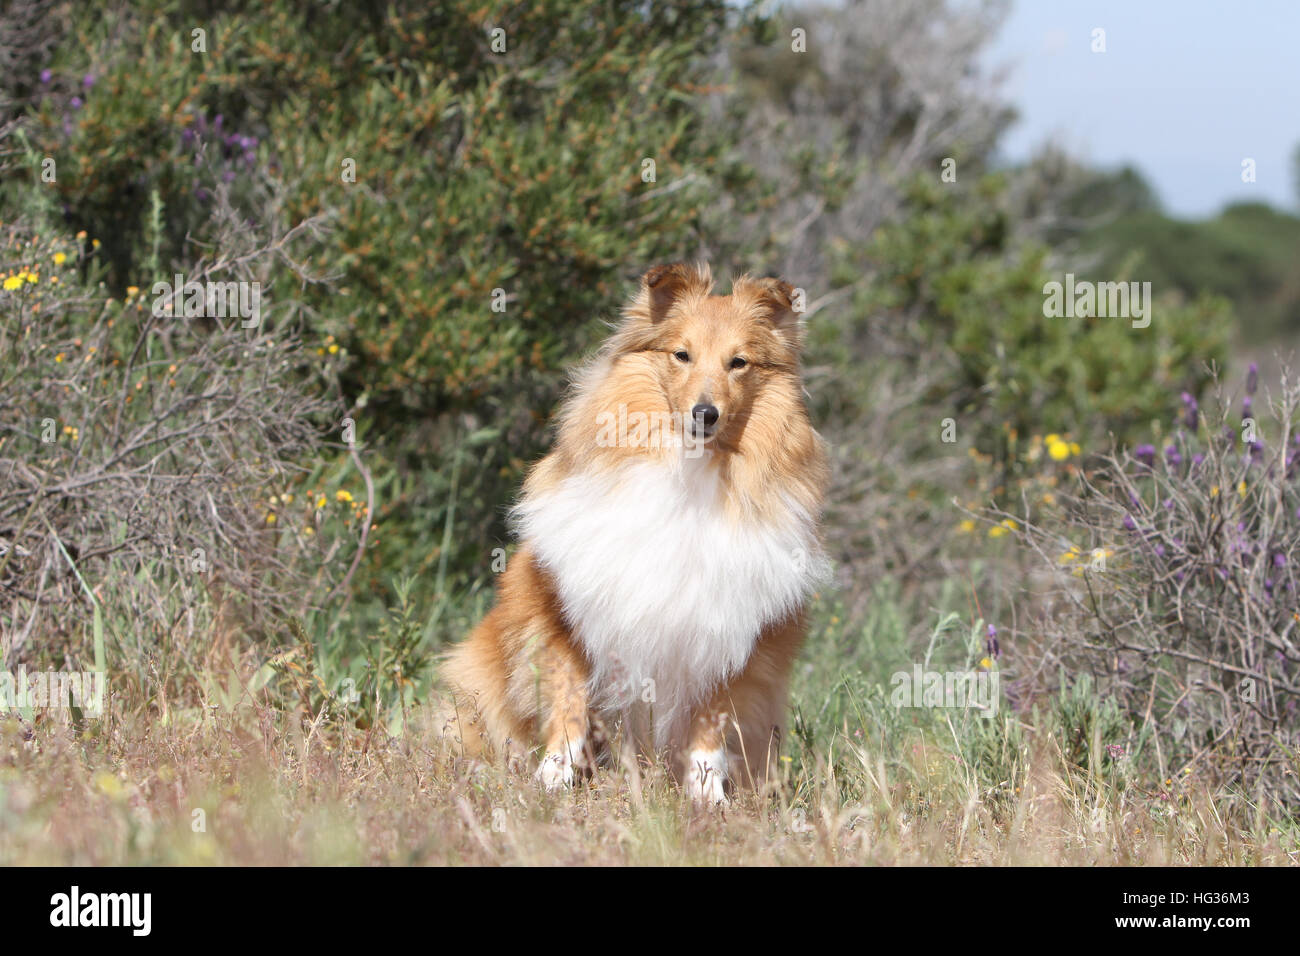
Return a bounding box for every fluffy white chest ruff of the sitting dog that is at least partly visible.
[515,459,827,744]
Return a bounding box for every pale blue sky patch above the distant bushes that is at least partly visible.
[988,0,1300,219]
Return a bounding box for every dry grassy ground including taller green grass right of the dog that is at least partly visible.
[0,590,1300,865]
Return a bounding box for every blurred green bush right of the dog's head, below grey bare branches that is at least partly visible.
[814,170,1231,470]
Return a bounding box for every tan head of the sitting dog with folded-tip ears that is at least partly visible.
[616,263,802,444]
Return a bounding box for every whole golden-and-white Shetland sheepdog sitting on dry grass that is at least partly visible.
[443,263,828,805]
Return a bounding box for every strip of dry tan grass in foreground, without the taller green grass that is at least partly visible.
[0,706,1296,865]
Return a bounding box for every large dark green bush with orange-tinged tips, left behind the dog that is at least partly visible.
[22,0,735,614]
